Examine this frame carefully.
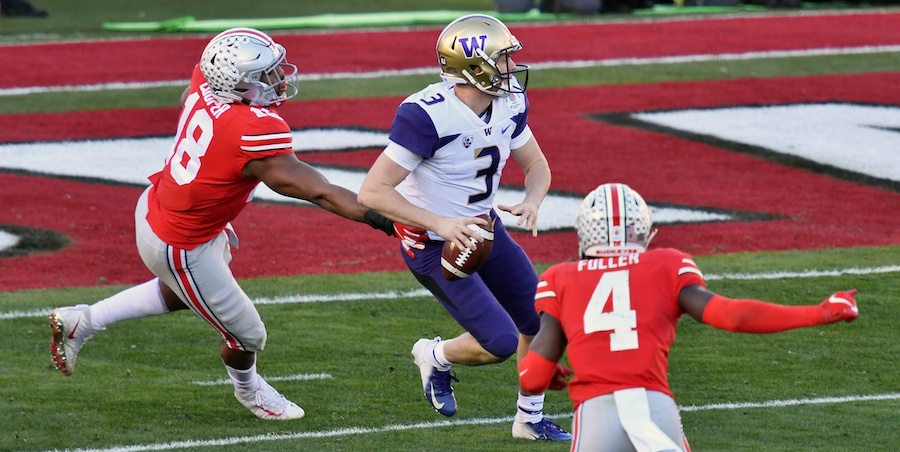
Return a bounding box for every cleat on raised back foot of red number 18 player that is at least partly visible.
[49,304,96,377]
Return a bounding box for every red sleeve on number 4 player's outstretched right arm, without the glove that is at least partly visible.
[703,295,822,333]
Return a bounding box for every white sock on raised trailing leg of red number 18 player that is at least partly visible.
[91,278,169,331]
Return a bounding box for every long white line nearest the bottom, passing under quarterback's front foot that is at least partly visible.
[54,393,900,452]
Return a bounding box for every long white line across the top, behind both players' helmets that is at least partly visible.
[0,45,900,97]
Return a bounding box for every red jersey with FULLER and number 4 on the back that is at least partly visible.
[535,248,706,408]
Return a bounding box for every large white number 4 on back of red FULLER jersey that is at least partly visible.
[584,270,638,352]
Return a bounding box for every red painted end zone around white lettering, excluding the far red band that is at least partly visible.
[0,74,900,290]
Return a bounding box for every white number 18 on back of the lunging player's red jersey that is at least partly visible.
[166,93,213,185]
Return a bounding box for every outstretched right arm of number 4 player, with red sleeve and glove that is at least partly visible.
[678,285,859,333]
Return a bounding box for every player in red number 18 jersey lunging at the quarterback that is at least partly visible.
[50,28,393,420]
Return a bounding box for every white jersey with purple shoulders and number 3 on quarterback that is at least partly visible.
[385,81,532,222]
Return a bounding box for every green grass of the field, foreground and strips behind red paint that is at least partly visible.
[0,0,900,451]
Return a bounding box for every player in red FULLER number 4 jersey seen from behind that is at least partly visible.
[519,184,859,451]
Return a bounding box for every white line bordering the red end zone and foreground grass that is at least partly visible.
[0,265,900,320]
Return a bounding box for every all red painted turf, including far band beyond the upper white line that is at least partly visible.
[0,13,900,290]
